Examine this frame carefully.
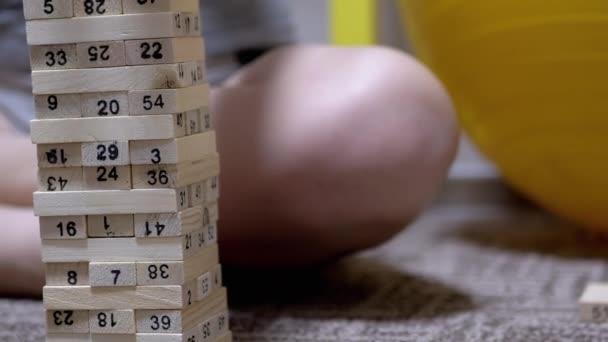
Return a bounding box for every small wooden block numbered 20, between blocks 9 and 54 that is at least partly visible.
[81,92,129,117]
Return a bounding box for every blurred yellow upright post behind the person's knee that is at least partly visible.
[329,0,378,45]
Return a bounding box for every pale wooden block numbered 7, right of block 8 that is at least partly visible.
[89,262,137,287]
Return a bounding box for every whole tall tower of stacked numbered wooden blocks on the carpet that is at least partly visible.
[24,0,232,342]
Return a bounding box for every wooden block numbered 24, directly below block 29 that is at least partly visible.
[84,165,131,190]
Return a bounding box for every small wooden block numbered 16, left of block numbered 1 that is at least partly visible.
[39,216,87,240]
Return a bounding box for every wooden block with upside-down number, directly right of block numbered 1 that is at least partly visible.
[134,207,202,238]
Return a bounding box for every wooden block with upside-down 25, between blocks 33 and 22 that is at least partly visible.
[76,40,127,68]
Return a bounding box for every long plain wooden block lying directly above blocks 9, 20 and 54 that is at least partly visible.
[32,62,196,95]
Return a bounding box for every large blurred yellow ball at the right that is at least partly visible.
[402,0,608,231]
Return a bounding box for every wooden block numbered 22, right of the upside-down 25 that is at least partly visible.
[125,36,205,65]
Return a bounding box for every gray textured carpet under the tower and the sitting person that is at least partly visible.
[0,205,608,342]
